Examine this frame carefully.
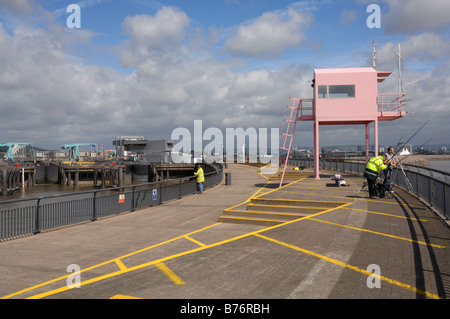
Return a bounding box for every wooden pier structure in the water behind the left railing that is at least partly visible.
[0,161,203,196]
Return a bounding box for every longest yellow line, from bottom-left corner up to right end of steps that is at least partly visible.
[19,203,351,299]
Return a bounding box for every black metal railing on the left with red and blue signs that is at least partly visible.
[0,164,223,241]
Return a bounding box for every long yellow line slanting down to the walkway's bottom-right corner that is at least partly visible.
[255,234,441,299]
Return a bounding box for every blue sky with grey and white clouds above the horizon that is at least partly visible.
[0,0,450,148]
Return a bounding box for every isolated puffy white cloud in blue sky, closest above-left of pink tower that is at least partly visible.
[225,9,308,57]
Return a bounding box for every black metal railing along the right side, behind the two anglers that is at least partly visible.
[288,159,450,219]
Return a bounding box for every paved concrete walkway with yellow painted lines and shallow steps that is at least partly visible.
[0,164,450,304]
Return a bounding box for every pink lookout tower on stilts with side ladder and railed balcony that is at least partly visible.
[280,67,406,186]
